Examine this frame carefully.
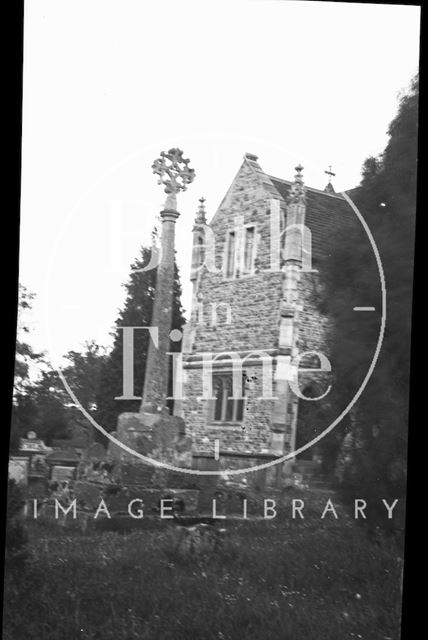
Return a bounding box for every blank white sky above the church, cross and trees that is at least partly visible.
[20,0,420,362]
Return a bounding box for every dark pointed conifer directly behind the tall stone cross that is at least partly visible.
[97,247,184,431]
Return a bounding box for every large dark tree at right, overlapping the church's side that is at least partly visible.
[324,78,418,504]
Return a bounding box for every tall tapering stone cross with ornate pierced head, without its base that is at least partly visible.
[140,149,195,413]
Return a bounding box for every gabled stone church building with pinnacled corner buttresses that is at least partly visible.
[174,153,359,478]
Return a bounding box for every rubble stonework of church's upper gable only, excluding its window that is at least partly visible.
[193,158,282,353]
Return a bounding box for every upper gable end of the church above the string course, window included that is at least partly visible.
[192,154,281,353]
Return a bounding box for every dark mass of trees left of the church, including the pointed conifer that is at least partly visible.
[11,242,184,452]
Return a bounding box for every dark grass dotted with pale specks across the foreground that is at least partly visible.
[3,492,402,640]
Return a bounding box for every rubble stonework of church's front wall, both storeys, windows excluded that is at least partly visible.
[182,162,282,460]
